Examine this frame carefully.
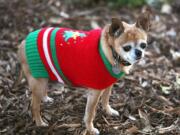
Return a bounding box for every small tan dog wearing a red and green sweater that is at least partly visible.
[18,12,150,134]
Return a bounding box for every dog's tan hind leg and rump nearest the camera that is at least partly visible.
[18,41,48,126]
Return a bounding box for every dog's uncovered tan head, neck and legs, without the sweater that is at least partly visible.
[18,13,149,134]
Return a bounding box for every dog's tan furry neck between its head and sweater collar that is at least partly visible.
[101,26,132,74]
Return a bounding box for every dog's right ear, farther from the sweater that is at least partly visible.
[136,11,151,31]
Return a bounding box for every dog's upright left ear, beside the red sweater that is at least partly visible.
[109,18,124,37]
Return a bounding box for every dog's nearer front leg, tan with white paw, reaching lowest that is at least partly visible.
[84,90,102,135]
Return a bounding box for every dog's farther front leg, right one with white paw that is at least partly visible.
[101,86,119,116]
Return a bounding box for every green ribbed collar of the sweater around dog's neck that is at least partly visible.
[99,40,125,79]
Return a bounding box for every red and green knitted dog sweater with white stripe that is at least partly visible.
[25,28,124,90]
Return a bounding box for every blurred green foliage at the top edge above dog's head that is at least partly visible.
[107,0,146,7]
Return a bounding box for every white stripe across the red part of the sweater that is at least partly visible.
[43,28,64,83]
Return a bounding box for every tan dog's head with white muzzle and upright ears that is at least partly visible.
[109,13,150,64]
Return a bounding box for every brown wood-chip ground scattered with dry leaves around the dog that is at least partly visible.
[0,0,180,135]
